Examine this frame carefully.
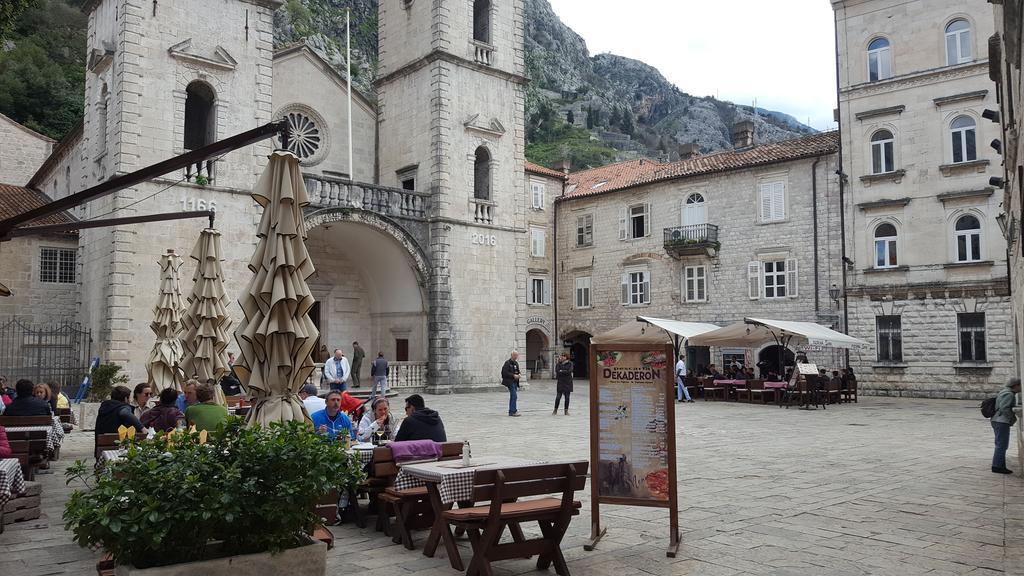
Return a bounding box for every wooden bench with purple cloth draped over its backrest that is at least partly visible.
[378,442,463,550]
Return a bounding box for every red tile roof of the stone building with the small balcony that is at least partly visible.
[564,131,839,198]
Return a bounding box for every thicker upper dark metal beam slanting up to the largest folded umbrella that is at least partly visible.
[0,120,288,240]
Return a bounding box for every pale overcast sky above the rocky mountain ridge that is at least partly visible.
[550,0,836,130]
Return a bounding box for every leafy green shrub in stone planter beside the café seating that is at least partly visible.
[63,418,364,576]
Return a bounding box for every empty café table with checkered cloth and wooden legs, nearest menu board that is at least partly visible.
[394,456,542,571]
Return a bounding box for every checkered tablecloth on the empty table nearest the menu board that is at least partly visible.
[394,456,541,504]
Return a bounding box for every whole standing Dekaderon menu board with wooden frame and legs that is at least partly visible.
[584,343,679,558]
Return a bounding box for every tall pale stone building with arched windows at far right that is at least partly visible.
[831,0,1014,398]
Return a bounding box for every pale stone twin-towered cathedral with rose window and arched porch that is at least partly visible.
[4,0,548,390]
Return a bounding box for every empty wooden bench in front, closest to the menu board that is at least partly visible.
[442,460,589,576]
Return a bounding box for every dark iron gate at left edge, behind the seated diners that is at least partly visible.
[0,318,92,398]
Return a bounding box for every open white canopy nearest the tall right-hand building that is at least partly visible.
[688,318,867,348]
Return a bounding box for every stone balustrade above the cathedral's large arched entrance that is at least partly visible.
[302,174,430,218]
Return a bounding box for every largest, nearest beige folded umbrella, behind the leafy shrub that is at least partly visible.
[234,151,319,425]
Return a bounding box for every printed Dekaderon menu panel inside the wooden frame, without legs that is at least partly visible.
[597,349,672,501]
